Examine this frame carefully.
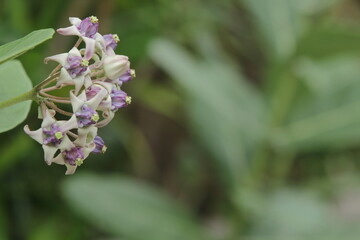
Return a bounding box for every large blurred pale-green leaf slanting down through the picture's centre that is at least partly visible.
[149,35,265,183]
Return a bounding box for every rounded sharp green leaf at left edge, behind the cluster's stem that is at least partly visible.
[0,60,32,133]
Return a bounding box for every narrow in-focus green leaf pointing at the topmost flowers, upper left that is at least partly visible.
[0,28,55,64]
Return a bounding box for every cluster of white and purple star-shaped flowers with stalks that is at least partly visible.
[24,16,135,174]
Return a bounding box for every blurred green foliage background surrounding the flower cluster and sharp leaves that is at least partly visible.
[0,0,360,240]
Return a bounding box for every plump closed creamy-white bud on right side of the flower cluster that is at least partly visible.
[104,55,130,80]
